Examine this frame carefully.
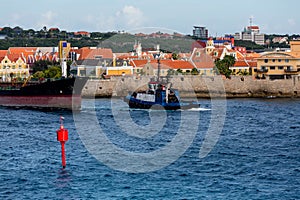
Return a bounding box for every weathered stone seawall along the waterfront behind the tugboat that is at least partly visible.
[82,76,300,98]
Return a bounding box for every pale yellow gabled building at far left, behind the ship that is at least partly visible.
[0,55,30,82]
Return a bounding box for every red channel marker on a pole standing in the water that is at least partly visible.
[56,116,68,169]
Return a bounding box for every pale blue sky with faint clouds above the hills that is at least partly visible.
[0,0,300,36]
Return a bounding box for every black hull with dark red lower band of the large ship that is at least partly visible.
[0,77,87,110]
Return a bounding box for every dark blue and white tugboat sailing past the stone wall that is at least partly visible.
[124,60,200,110]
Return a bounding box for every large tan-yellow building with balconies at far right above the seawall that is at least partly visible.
[253,41,300,80]
